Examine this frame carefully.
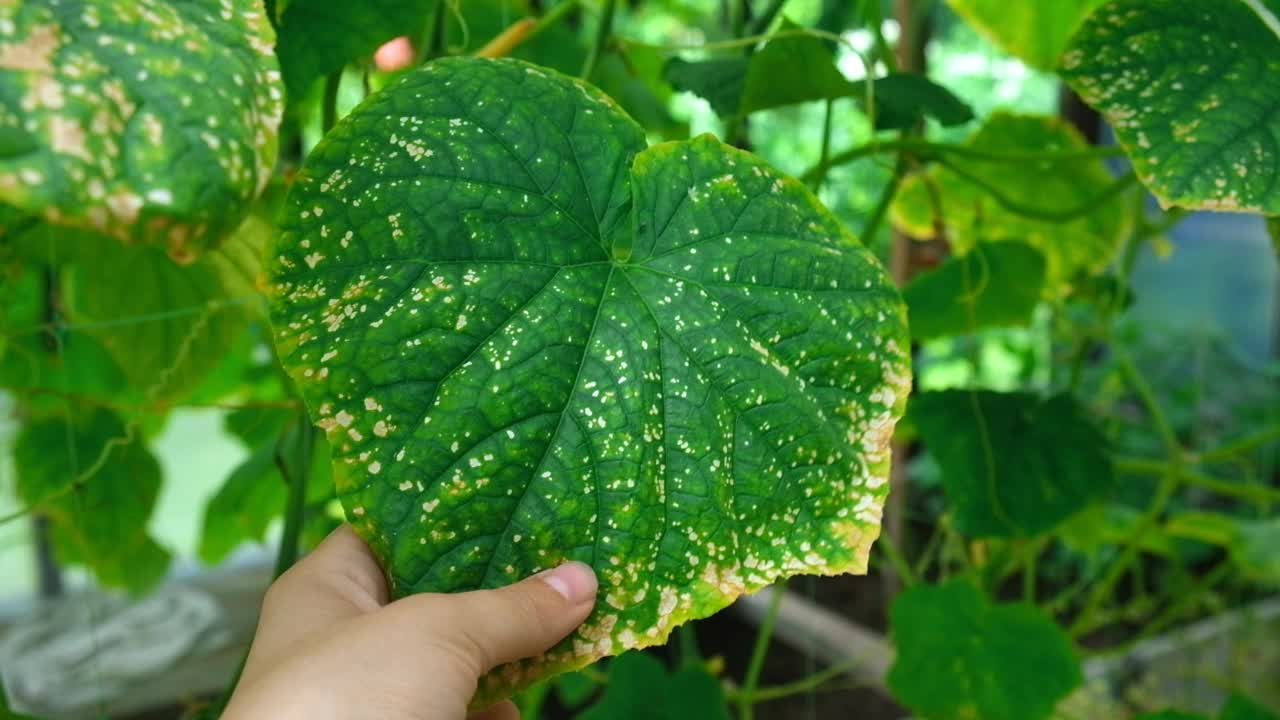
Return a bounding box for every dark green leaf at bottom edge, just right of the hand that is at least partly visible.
[577,652,728,720]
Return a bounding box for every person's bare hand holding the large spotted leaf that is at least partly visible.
[223,525,596,720]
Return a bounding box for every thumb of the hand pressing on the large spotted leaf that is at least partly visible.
[401,562,596,673]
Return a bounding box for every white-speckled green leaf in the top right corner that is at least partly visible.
[1060,0,1280,214]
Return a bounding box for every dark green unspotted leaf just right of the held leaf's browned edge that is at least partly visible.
[910,389,1115,537]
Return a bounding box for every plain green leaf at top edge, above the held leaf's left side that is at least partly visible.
[275,0,444,104]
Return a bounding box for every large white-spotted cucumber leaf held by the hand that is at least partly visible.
[271,59,910,697]
